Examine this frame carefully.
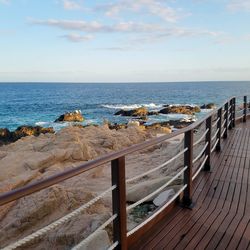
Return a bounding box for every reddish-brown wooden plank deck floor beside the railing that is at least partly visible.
[137,122,250,250]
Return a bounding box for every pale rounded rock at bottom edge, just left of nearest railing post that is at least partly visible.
[73,230,111,250]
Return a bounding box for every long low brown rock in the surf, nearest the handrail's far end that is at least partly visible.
[159,105,201,115]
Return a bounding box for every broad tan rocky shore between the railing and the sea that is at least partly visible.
[0,103,215,249]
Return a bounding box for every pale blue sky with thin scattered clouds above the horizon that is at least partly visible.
[0,0,250,82]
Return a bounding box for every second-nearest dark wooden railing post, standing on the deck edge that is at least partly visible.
[182,129,193,208]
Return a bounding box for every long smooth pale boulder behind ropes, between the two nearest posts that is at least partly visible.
[127,177,183,202]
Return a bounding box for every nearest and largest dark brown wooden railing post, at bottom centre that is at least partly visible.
[111,156,127,250]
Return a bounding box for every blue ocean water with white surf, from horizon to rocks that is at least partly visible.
[0,81,250,130]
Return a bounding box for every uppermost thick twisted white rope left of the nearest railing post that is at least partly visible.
[2,185,116,250]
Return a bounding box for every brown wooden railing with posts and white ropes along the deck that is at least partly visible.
[0,96,248,249]
